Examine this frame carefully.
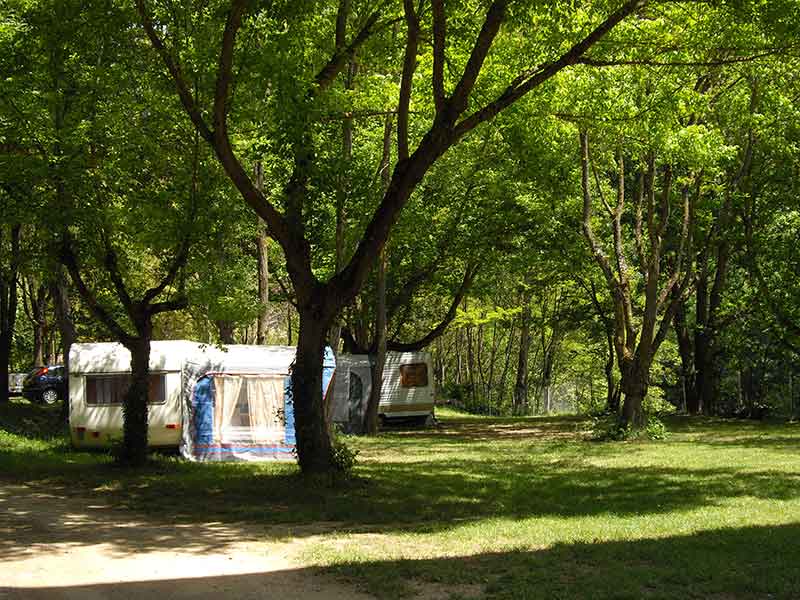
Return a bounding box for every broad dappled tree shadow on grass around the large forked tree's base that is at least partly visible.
[0,398,800,558]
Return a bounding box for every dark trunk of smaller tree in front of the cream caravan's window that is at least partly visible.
[117,336,150,466]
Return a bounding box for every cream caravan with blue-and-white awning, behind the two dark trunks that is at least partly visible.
[69,340,335,461]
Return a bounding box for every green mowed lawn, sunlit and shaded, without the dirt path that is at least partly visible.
[0,401,800,600]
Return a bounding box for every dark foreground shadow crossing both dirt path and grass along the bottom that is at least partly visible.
[0,524,800,600]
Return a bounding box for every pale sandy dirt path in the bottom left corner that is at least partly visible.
[0,483,371,600]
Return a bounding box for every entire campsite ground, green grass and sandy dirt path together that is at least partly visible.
[0,401,800,600]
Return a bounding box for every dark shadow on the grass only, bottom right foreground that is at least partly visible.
[331,524,800,600]
